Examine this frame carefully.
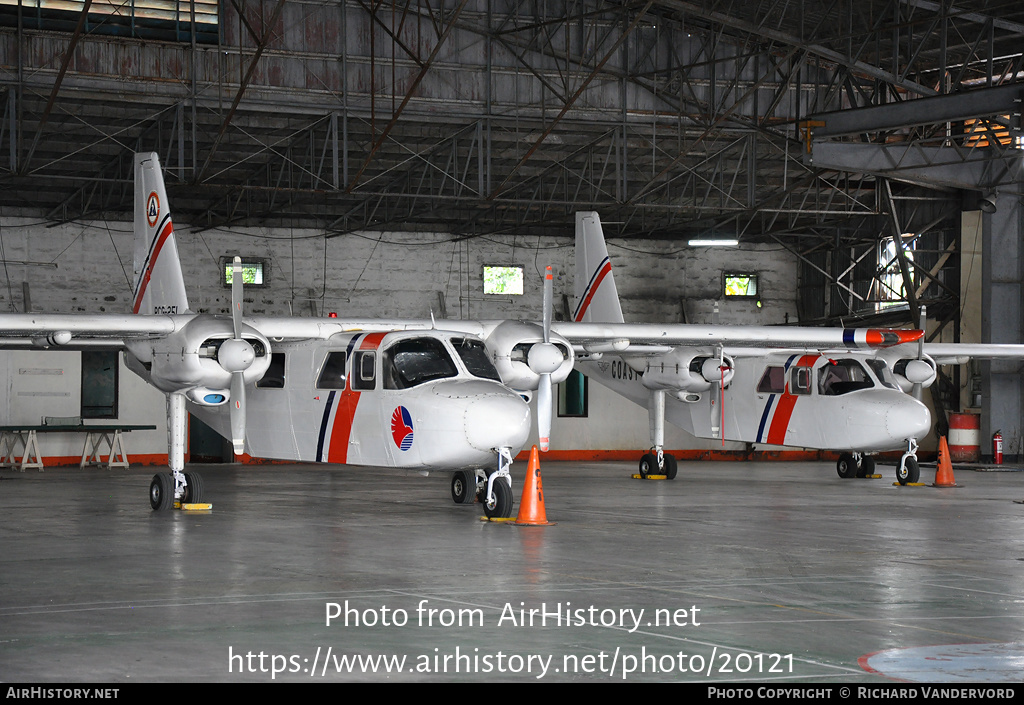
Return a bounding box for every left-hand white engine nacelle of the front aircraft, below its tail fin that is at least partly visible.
[125,316,270,393]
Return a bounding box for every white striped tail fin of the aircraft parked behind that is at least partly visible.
[572,211,623,323]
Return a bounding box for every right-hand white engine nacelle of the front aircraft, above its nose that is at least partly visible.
[483,321,575,391]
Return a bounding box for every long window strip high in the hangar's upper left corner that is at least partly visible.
[0,0,220,44]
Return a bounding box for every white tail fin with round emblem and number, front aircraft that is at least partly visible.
[132,152,188,314]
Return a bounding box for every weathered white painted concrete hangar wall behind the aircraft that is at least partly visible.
[0,217,797,463]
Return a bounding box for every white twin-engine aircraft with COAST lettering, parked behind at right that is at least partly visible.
[569,212,1024,485]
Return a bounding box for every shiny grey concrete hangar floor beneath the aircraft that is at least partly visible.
[0,462,1024,686]
